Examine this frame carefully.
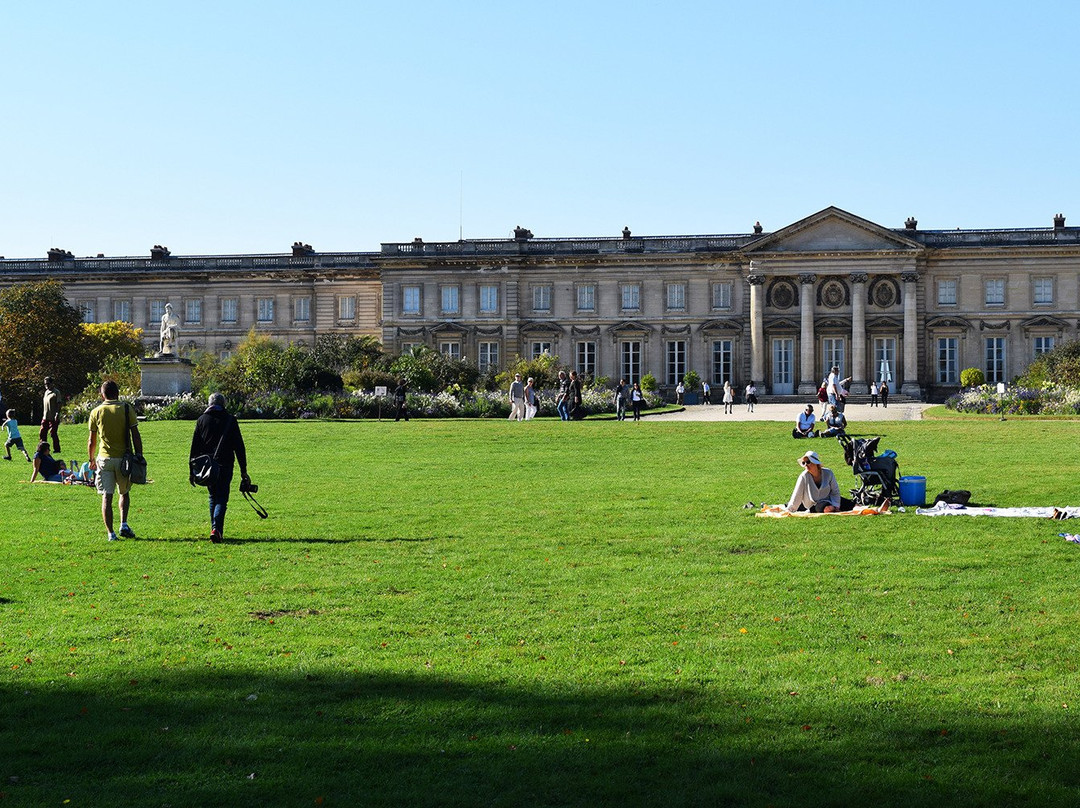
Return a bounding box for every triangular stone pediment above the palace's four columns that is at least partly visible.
[743,207,922,255]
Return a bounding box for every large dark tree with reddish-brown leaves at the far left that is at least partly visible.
[0,281,95,423]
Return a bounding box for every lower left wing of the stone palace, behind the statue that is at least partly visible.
[0,242,381,356]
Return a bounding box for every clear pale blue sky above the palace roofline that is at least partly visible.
[0,0,1080,258]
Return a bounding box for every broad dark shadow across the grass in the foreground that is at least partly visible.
[6,671,1080,806]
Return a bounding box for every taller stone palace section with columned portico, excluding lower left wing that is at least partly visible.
[376,207,1080,399]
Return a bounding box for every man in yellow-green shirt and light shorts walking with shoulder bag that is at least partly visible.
[86,381,143,541]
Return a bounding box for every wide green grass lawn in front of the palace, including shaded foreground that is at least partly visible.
[0,419,1080,806]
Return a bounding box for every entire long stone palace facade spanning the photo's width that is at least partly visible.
[0,207,1080,400]
